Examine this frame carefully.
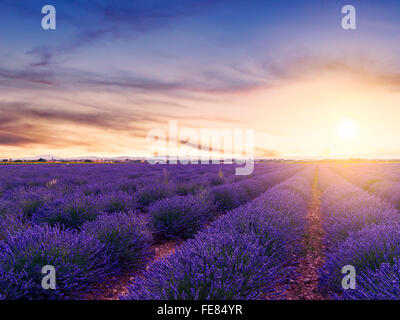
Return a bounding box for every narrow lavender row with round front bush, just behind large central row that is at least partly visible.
[149,166,302,239]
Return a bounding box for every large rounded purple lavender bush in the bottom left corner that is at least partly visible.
[0,225,114,300]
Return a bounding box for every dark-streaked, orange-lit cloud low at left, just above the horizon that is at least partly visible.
[0,100,241,150]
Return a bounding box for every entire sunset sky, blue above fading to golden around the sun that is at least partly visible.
[0,0,400,158]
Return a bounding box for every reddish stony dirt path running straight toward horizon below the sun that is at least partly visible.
[284,168,329,300]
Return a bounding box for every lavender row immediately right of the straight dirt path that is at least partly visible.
[320,167,400,299]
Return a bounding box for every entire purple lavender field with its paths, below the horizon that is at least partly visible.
[0,163,400,300]
